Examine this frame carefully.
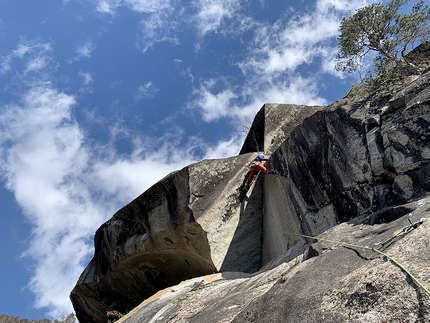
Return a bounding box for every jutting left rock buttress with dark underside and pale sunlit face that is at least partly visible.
[71,104,322,323]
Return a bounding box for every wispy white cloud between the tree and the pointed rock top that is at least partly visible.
[189,0,372,122]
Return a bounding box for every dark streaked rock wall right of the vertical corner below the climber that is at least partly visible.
[263,63,430,263]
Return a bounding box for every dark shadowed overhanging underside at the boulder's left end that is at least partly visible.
[71,169,216,322]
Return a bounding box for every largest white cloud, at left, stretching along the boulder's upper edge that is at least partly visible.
[0,83,242,317]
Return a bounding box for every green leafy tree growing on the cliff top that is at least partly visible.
[335,0,430,76]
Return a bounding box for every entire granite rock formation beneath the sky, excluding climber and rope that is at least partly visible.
[71,45,430,323]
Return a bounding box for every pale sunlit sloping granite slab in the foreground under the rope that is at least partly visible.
[119,198,430,323]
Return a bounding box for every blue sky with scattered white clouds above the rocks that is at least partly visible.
[0,0,369,319]
